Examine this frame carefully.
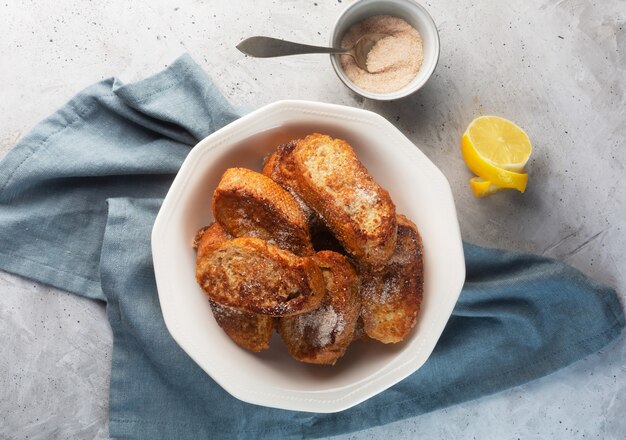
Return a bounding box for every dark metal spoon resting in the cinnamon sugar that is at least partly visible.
[237,33,389,72]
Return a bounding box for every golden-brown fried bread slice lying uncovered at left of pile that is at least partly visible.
[196,237,324,316]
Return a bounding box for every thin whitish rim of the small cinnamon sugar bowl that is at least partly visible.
[330,0,441,101]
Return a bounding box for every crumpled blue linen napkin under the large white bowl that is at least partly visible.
[0,56,625,439]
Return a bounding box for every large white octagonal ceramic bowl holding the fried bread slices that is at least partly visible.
[152,101,465,413]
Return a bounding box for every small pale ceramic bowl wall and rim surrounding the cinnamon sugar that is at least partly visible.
[330,0,439,101]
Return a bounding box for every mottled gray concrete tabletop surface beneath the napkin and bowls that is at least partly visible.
[0,0,626,440]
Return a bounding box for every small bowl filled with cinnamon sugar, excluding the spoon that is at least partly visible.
[330,0,439,101]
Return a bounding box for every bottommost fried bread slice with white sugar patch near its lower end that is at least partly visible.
[277,251,360,365]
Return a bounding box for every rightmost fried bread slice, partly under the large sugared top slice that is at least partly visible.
[360,215,424,343]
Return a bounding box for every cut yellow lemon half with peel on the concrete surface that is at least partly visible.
[461,116,532,192]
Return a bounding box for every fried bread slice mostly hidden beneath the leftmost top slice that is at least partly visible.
[194,223,274,352]
